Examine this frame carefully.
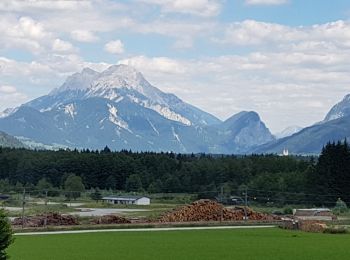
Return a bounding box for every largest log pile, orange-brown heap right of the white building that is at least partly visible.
[159,200,278,222]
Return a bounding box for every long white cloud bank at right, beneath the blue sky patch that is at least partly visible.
[217,20,350,49]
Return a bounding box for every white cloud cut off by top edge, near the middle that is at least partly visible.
[140,0,221,17]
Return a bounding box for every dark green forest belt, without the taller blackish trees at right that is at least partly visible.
[0,145,311,192]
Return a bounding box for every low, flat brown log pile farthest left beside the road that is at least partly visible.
[12,213,79,227]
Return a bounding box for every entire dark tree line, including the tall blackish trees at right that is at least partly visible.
[0,143,350,204]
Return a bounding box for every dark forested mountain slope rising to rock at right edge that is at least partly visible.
[253,95,350,154]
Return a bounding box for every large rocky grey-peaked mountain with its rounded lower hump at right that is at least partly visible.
[0,65,273,153]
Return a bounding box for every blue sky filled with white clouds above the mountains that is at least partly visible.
[0,0,350,133]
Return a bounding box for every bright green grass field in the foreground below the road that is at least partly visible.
[9,228,350,260]
